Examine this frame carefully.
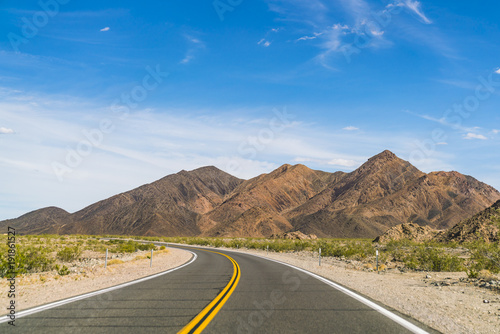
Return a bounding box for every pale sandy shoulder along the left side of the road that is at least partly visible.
[0,248,192,315]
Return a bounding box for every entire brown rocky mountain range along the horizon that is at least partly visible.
[0,151,500,238]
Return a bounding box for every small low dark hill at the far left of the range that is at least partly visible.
[0,206,71,234]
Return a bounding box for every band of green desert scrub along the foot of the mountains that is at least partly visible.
[0,235,500,278]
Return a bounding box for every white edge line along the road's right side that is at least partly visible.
[169,243,429,334]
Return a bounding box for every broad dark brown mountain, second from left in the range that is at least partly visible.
[62,167,242,236]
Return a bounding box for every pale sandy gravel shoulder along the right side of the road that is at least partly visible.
[228,250,500,334]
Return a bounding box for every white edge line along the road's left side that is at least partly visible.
[0,249,198,324]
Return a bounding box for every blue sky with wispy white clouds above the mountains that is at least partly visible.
[0,0,500,219]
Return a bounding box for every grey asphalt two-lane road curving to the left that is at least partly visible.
[0,247,442,334]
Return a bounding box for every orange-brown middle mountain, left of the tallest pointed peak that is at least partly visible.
[205,165,345,237]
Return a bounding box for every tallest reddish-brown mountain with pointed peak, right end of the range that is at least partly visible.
[286,151,500,237]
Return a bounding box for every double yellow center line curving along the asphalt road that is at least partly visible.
[177,251,241,334]
